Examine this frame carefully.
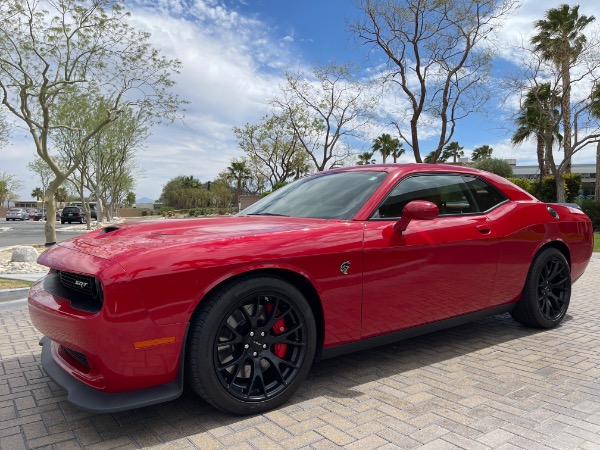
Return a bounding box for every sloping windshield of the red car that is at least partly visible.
[239,171,387,220]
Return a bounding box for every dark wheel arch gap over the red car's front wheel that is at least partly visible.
[189,268,325,361]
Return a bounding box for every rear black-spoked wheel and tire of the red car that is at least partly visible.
[510,248,571,328]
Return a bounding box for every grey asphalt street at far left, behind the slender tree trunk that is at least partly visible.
[0,218,84,248]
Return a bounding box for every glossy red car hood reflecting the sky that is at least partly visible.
[57,216,340,260]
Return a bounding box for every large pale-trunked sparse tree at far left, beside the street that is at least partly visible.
[0,0,181,245]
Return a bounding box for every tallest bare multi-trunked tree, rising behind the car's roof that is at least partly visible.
[351,0,515,162]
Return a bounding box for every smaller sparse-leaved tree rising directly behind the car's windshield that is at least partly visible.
[273,64,376,171]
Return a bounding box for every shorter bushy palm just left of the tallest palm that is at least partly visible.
[511,83,562,183]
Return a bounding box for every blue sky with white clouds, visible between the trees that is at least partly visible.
[0,0,600,200]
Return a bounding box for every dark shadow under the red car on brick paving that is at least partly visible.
[0,314,570,447]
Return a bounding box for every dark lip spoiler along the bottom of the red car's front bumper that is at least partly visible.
[40,337,184,413]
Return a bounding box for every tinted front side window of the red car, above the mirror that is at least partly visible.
[372,175,477,220]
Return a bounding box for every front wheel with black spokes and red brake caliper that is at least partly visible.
[186,276,317,415]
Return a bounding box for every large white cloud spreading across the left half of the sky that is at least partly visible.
[0,0,291,199]
